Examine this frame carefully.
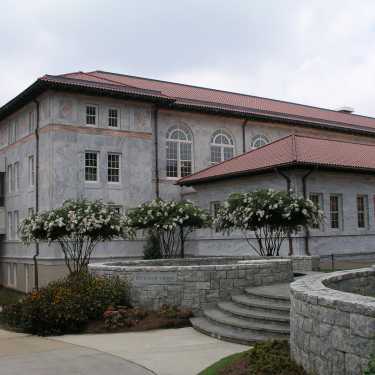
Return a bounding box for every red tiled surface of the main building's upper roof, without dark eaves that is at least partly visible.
[64,71,375,133]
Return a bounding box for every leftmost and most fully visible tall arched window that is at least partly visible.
[167,127,193,177]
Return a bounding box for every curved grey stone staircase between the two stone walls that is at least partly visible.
[191,284,290,345]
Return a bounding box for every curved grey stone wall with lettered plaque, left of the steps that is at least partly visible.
[89,258,293,312]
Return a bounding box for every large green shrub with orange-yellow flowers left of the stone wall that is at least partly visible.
[2,273,129,336]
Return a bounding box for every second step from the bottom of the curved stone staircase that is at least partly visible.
[204,309,290,336]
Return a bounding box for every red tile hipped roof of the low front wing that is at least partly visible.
[177,135,375,185]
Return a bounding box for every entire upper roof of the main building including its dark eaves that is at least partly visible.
[0,71,375,134]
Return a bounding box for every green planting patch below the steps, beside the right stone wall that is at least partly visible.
[199,340,307,375]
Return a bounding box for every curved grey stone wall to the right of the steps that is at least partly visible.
[290,268,375,375]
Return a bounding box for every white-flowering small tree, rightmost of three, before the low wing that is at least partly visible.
[215,189,323,256]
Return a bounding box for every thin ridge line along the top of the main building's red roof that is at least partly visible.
[90,70,375,120]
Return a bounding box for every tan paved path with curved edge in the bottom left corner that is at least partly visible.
[0,330,155,375]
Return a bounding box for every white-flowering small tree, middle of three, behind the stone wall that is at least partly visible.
[127,199,210,258]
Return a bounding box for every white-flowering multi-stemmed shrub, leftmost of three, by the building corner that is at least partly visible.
[19,200,133,273]
